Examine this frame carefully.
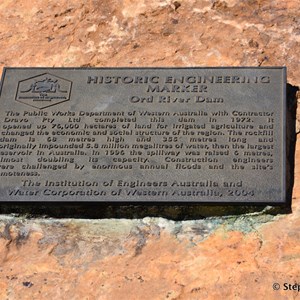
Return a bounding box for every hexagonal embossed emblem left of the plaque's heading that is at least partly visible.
[16,73,72,109]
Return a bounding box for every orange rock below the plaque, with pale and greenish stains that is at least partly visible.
[0,199,300,299]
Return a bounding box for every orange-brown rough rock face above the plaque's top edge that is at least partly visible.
[0,0,300,86]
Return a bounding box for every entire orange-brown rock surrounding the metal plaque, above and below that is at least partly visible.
[0,0,300,300]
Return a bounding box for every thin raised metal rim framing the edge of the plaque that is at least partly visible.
[0,66,294,207]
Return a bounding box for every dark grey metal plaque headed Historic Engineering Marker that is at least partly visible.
[0,67,287,204]
